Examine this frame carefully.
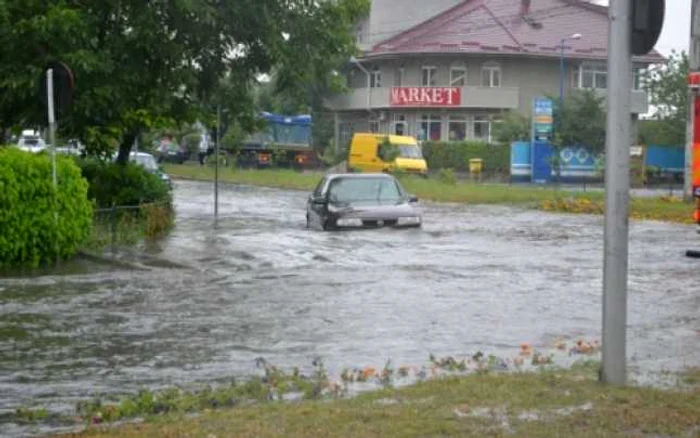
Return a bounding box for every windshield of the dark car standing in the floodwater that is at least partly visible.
[329,178,403,203]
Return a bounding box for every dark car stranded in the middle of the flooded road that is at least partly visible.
[306,173,423,231]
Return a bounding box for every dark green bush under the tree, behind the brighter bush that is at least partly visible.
[78,158,172,208]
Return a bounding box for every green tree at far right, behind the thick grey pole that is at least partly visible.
[639,51,689,145]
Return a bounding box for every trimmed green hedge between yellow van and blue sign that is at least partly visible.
[423,142,510,173]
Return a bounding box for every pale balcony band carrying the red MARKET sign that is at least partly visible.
[326,87,520,111]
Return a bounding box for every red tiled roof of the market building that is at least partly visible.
[366,0,665,63]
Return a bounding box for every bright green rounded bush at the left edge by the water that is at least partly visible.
[0,148,93,268]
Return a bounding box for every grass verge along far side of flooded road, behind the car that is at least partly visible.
[165,165,694,224]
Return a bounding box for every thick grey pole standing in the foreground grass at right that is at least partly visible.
[600,0,632,385]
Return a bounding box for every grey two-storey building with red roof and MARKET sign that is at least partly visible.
[327,0,664,144]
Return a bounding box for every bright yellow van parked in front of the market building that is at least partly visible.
[348,133,428,176]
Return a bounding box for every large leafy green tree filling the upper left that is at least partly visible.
[0,0,368,163]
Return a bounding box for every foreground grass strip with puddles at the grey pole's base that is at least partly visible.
[62,366,700,438]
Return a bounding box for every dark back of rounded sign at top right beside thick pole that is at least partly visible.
[630,0,666,56]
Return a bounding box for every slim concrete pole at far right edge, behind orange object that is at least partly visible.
[683,0,700,201]
